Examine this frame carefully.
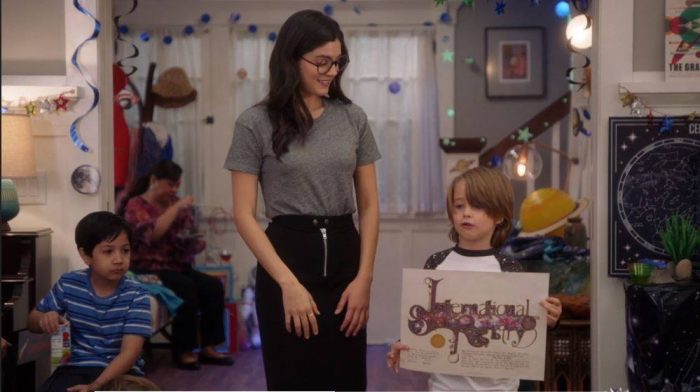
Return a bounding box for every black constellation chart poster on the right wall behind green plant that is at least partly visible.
[608,117,700,277]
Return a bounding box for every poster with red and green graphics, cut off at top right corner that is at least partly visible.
[665,0,700,79]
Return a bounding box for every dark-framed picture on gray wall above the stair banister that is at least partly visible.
[485,27,546,99]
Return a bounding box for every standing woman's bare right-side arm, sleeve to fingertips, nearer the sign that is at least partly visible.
[335,163,379,336]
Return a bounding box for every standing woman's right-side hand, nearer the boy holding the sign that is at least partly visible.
[335,277,372,337]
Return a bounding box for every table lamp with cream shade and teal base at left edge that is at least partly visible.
[0,114,36,231]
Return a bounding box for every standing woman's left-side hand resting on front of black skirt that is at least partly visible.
[280,282,321,339]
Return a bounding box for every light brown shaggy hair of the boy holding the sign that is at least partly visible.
[447,167,514,249]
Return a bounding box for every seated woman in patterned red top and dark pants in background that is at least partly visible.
[123,161,233,370]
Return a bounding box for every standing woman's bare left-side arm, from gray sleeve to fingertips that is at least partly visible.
[231,170,321,339]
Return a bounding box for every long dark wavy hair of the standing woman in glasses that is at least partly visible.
[261,10,352,159]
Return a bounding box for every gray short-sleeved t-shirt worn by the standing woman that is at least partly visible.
[224,99,380,218]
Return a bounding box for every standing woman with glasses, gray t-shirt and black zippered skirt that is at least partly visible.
[226,10,380,390]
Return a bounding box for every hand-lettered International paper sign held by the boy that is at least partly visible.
[401,269,549,380]
